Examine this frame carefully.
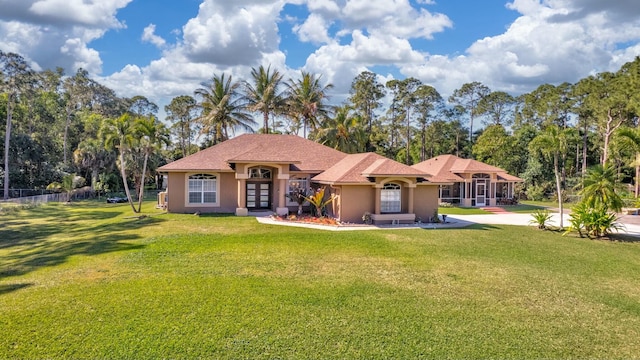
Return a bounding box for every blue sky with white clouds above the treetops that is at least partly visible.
[0,0,640,118]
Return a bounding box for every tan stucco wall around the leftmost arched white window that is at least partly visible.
[167,173,238,213]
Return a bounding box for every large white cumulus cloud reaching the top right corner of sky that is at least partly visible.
[401,0,640,93]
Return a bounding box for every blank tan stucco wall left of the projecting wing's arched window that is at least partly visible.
[335,185,375,223]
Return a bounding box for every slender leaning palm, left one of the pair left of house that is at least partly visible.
[103,114,137,213]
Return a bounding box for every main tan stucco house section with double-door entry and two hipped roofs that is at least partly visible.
[158,134,456,223]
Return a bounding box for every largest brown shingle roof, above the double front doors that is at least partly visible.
[158,134,347,172]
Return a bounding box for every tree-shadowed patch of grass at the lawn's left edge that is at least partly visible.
[0,202,164,278]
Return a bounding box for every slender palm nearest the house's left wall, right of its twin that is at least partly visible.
[135,115,171,213]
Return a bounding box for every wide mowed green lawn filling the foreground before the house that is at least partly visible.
[0,202,640,359]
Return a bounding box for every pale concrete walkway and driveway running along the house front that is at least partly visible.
[256,213,640,237]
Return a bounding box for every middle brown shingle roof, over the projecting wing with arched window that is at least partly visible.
[312,153,427,184]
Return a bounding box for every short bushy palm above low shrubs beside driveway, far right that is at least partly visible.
[580,164,623,212]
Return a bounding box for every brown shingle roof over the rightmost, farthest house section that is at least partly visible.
[413,155,522,182]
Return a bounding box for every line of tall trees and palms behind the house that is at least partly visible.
[0,52,640,210]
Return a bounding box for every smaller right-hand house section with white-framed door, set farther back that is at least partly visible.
[413,155,523,206]
